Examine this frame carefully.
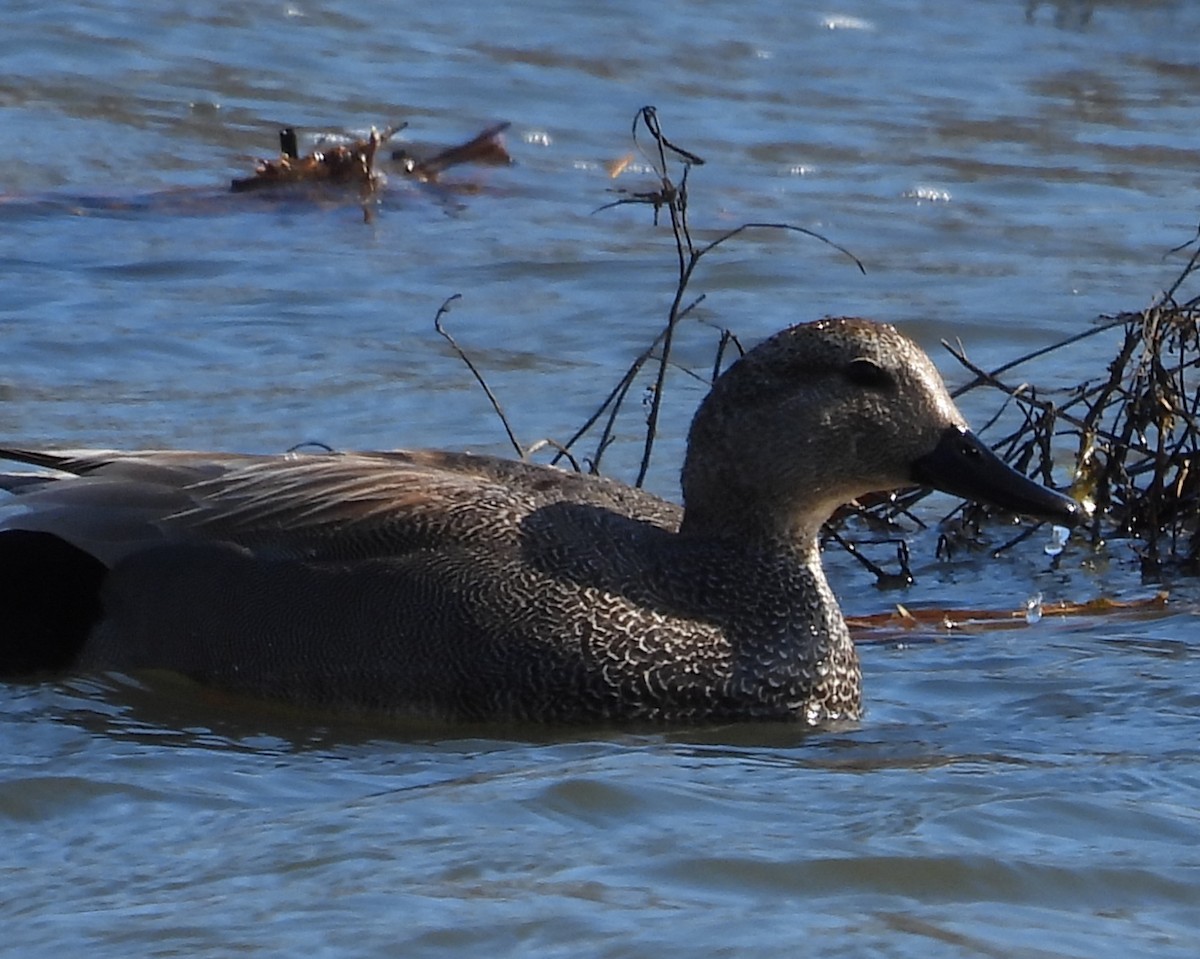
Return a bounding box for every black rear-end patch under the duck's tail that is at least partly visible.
[0,529,108,677]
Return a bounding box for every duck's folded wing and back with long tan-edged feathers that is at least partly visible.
[0,448,679,565]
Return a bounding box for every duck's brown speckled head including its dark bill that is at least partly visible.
[683,318,1084,540]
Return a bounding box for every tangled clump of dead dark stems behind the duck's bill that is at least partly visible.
[950,233,1200,579]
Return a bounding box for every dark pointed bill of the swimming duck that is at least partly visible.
[912,426,1087,526]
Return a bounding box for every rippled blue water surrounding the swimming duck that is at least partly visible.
[0,0,1200,959]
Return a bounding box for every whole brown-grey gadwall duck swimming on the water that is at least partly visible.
[0,319,1080,724]
